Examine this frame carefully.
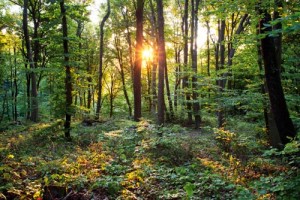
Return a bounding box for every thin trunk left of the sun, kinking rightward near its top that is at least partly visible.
[96,0,110,119]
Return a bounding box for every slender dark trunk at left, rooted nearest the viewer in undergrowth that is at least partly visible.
[60,0,73,140]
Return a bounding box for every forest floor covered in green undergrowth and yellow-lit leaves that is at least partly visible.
[0,116,300,200]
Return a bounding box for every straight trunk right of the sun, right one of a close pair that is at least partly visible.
[191,0,201,129]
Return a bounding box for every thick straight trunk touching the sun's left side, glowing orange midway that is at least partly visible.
[133,0,144,121]
